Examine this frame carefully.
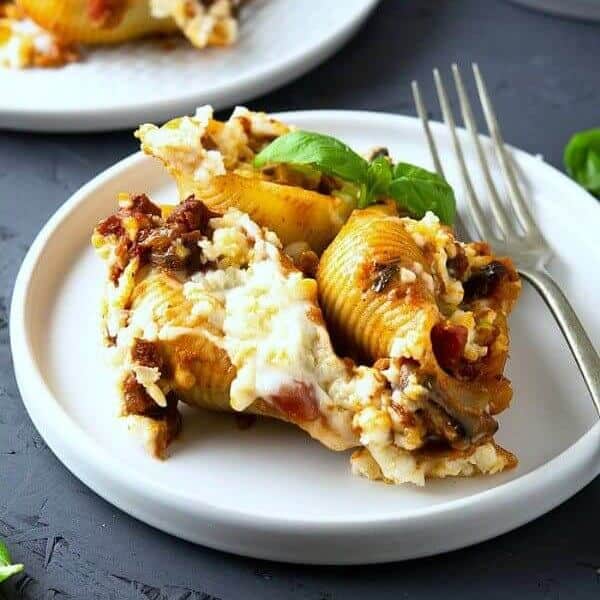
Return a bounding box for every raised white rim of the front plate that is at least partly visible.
[10,110,600,564]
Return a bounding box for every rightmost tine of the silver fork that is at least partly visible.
[473,63,542,238]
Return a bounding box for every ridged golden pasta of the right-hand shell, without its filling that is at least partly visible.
[317,207,512,440]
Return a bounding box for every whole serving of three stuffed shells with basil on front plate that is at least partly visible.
[92,109,520,485]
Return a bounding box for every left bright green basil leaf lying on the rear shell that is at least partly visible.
[254,130,369,183]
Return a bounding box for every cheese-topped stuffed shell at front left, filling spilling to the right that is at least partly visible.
[92,195,515,485]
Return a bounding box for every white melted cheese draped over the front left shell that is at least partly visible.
[184,210,346,410]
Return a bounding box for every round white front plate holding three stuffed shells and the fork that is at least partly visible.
[11,111,600,564]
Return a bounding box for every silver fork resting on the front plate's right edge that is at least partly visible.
[412,64,600,416]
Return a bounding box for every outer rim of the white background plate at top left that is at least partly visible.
[0,0,380,132]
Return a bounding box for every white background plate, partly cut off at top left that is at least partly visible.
[0,0,378,132]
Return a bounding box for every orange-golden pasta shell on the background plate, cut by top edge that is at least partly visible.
[18,0,178,44]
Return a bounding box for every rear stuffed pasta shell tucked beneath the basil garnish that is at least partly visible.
[136,106,353,253]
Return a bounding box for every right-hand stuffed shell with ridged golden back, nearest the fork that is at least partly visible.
[317,206,520,476]
